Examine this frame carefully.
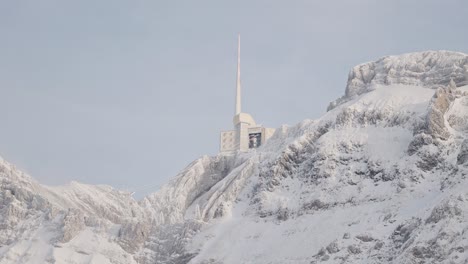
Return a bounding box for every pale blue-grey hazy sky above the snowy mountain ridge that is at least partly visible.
[0,0,468,198]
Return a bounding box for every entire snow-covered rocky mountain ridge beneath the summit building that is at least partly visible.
[0,51,468,264]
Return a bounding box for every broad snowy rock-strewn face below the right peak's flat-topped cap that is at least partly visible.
[188,85,468,263]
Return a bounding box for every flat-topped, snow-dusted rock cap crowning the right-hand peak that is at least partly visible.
[328,51,468,110]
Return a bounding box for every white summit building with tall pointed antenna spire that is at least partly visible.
[220,34,275,152]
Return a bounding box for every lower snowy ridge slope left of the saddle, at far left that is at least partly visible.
[0,158,143,263]
